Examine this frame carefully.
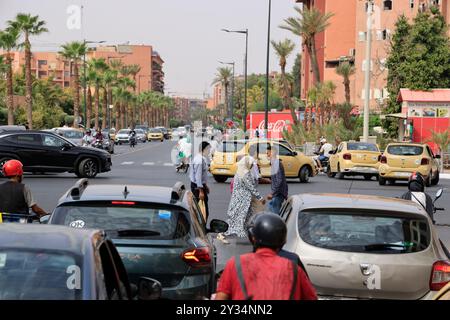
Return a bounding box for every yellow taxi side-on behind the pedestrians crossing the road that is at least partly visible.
[210,139,317,183]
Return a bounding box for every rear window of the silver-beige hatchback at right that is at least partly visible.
[298,211,431,254]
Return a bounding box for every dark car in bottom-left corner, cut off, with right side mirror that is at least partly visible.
[0,224,161,300]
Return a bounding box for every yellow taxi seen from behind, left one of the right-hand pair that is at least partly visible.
[327,141,381,180]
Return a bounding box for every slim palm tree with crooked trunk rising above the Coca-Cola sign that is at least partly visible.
[272,39,298,125]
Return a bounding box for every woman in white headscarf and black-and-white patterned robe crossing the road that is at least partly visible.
[218,156,265,240]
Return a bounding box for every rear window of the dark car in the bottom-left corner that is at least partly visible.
[0,248,83,300]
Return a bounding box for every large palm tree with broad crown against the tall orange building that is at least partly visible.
[280,7,334,83]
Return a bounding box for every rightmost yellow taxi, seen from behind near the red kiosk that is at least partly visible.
[378,143,440,187]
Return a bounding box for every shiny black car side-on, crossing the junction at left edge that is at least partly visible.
[0,130,112,178]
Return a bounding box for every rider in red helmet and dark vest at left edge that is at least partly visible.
[0,160,47,217]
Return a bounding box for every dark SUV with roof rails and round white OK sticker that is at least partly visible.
[48,179,228,299]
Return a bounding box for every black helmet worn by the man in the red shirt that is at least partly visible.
[248,213,287,249]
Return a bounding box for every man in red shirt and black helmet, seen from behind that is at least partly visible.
[216,213,317,300]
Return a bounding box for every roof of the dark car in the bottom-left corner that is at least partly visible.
[0,223,104,255]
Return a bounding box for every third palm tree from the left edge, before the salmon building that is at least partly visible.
[59,41,87,128]
